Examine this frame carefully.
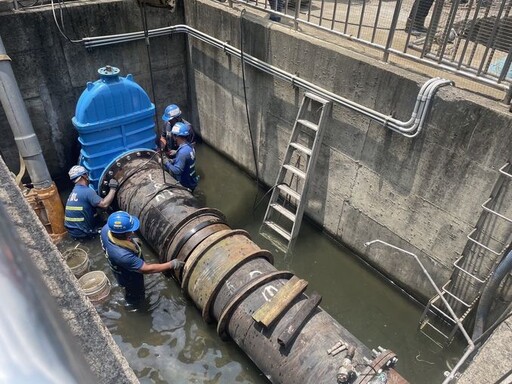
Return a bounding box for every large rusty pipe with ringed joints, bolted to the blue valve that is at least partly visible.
[100,150,406,384]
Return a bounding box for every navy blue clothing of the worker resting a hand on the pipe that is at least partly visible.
[100,225,145,304]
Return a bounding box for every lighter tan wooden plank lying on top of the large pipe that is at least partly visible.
[252,276,308,328]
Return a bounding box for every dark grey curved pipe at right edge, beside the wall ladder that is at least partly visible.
[472,251,512,341]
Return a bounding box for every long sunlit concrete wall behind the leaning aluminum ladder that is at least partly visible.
[185,0,512,300]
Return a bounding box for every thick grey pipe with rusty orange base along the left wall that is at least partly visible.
[0,36,66,241]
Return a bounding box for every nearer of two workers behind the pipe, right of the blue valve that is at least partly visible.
[164,123,199,192]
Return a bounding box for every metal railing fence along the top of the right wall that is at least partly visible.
[224,0,512,103]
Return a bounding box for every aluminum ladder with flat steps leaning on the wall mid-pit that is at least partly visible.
[260,92,332,254]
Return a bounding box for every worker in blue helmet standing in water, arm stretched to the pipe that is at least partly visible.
[100,211,184,306]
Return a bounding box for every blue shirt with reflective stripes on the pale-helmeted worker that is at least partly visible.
[64,184,101,238]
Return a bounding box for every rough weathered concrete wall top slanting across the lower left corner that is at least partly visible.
[0,154,139,384]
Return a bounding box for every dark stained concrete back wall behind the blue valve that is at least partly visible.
[0,1,188,186]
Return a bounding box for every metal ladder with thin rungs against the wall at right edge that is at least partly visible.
[419,161,512,347]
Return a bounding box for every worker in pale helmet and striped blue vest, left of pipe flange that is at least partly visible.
[64,165,119,240]
